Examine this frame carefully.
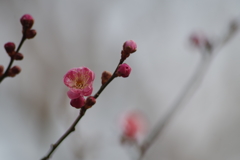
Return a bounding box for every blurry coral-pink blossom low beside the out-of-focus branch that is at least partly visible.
[120,111,146,140]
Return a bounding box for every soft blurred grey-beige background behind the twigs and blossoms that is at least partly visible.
[0,0,240,160]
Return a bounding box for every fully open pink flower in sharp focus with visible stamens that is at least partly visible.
[63,67,95,99]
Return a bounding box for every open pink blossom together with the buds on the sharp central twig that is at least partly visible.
[63,40,137,108]
